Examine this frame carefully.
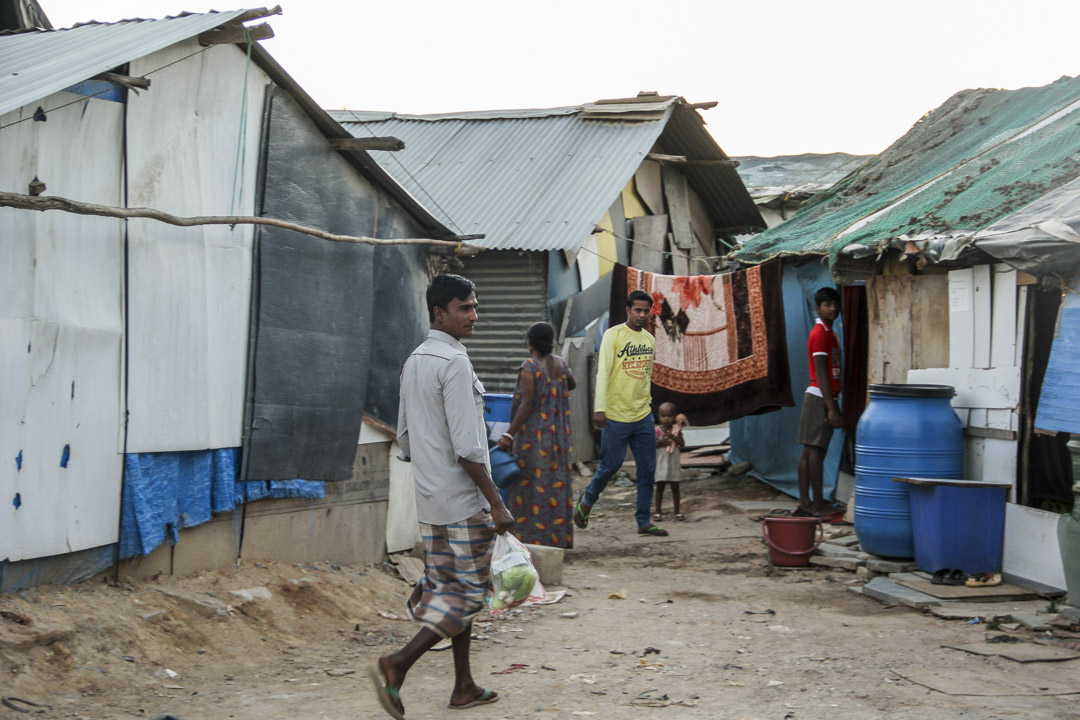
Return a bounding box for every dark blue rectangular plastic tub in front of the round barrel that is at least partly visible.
[894,477,1012,575]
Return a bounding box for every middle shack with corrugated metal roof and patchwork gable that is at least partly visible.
[330,93,765,395]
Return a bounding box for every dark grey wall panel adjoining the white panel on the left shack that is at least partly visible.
[244,89,380,480]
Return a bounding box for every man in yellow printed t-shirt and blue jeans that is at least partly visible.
[573,290,667,535]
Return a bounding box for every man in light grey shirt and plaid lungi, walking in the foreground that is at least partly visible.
[370,274,514,720]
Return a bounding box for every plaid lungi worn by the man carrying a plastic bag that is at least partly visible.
[406,511,495,638]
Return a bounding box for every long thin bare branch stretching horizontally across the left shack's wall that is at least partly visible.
[0,192,484,250]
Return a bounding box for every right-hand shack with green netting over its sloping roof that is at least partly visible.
[732,78,1080,587]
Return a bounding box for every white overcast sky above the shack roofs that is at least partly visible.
[39,0,1080,155]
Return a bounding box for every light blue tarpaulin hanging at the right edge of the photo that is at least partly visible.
[1035,281,1080,433]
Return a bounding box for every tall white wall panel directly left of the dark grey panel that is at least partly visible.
[127,39,270,452]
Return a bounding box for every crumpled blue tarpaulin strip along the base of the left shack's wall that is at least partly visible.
[120,448,323,558]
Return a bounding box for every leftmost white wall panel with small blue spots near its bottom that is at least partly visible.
[0,93,123,561]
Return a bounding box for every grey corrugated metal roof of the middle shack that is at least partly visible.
[330,98,765,252]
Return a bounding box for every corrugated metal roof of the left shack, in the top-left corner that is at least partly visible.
[0,10,246,114]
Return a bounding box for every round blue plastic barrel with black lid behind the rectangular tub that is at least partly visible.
[855,384,963,558]
